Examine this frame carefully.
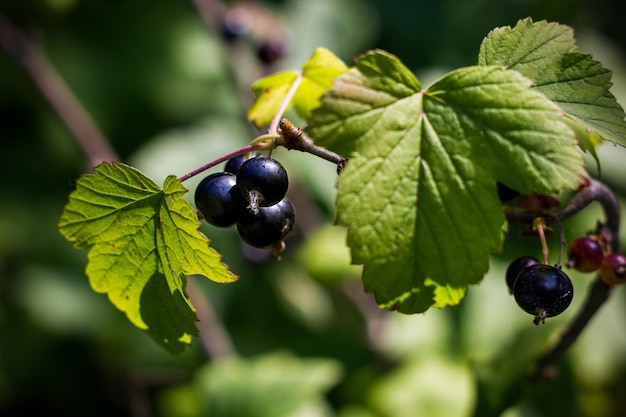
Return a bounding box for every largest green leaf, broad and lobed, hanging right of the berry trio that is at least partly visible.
[307,51,584,312]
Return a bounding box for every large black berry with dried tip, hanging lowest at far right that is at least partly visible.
[513,264,574,324]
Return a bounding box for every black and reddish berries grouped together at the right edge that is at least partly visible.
[506,236,626,323]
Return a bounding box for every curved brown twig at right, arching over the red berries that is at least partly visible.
[504,180,620,378]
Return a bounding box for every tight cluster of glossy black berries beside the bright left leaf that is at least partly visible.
[195,155,296,248]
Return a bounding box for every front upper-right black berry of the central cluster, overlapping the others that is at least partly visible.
[237,156,289,207]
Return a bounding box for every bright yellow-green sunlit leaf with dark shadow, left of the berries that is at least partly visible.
[59,163,237,353]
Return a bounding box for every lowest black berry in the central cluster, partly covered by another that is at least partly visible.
[237,198,296,248]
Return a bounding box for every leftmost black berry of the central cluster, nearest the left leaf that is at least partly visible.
[195,172,247,227]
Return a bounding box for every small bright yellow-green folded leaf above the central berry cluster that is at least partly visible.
[248,48,347,127]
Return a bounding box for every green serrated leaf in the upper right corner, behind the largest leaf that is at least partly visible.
[478,18,626,148]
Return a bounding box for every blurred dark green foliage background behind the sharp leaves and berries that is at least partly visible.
[0,0,626,417]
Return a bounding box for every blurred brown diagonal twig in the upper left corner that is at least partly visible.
[0,13,118,166]
